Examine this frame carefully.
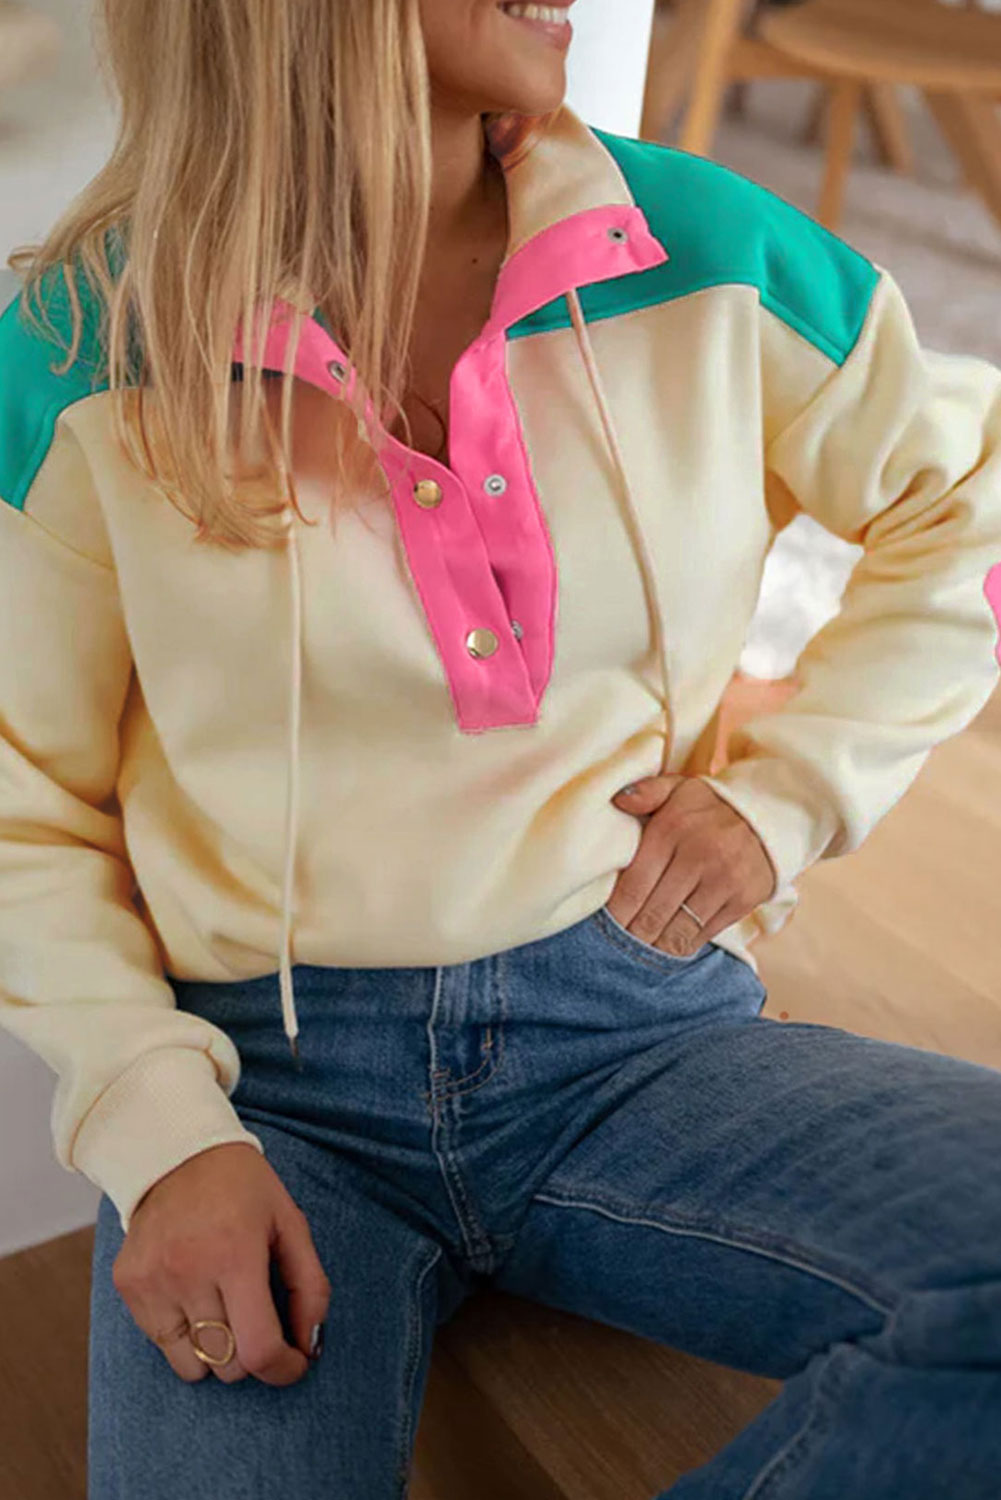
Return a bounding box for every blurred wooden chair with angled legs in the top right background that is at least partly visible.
[641,0,1001,233]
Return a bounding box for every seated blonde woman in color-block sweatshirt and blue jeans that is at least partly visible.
[0,0,1001,1500]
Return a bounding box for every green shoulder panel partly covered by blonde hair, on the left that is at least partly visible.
[0,261,108,510]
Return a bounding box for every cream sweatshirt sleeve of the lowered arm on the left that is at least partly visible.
[0,396,264,1232]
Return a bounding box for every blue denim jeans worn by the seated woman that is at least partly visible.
[89,909,1001,1500]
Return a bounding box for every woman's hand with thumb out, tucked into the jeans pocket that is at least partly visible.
[606,776,776,956]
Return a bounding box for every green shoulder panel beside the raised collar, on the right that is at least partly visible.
[509,126,879,365]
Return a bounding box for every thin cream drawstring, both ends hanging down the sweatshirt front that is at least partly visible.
[279,288,671,1068]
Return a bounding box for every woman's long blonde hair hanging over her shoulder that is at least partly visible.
[8,0,518,549]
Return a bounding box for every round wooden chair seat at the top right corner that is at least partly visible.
[756,0,1001,98]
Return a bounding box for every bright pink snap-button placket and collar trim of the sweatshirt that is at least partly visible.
[233,204,669,734]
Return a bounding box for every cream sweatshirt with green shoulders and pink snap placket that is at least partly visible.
[0,107,1001,1230]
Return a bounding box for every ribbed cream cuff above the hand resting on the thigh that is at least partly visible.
[71,1047,264,1235]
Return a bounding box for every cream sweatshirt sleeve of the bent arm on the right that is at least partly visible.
[699,267,1001,900]
